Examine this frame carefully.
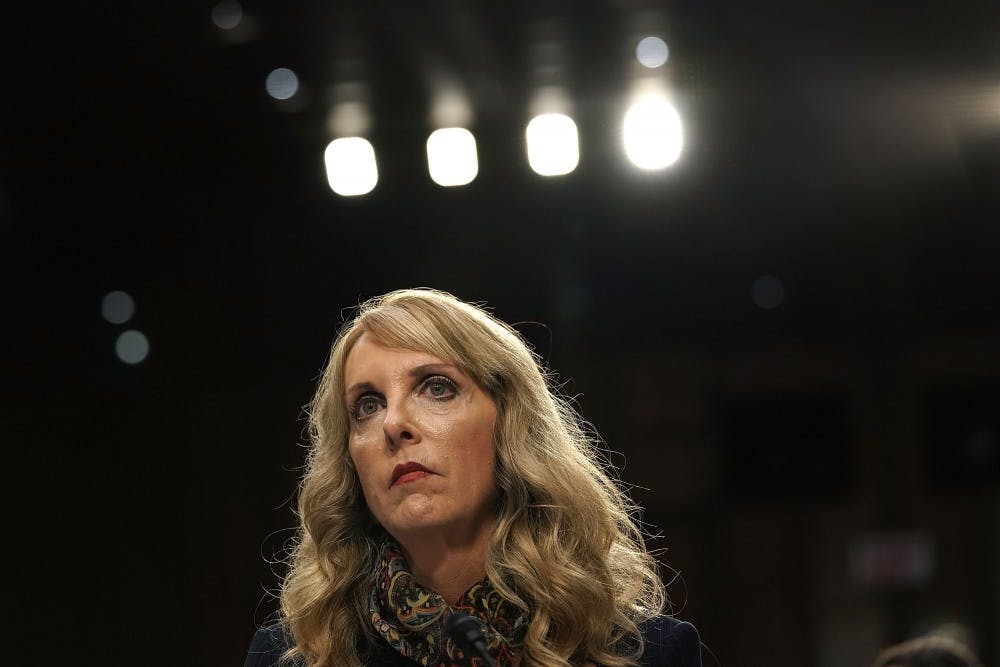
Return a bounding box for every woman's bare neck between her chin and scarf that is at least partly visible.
[396,525,493,605]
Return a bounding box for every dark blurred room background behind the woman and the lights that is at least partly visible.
[0,1,1000,667]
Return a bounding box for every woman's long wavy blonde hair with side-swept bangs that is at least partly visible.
[281,289,665,667]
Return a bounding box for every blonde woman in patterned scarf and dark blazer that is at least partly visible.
[246,290,700,667]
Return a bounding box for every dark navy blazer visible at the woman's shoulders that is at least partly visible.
[243,616,701,667]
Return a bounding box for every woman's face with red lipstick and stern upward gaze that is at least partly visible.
[344,333,497,542]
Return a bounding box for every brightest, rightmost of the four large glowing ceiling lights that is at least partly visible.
[624,95,684,169]
